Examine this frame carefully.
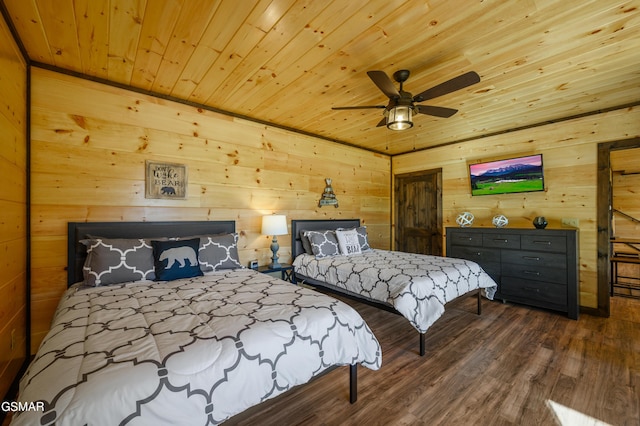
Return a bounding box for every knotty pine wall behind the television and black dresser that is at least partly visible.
[392,108,640,308]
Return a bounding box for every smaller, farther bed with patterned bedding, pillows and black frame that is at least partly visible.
[291,219,497,355]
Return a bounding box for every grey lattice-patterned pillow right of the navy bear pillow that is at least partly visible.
[198,233,243,272]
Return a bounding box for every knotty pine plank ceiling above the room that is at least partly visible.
[2,0,640,155]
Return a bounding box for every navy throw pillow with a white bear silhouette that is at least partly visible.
[151,238,202,281]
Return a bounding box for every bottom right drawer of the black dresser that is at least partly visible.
[500,277,567,308]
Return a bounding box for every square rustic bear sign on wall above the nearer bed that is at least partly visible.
[145,161,187,200]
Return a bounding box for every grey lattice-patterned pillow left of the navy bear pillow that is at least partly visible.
[80,237,155,287]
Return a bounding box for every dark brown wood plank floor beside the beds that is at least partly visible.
[230,297,640,426]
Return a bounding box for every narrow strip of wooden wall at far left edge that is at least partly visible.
[0,15,27,395]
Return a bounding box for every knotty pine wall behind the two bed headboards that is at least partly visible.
[31,68,391,351]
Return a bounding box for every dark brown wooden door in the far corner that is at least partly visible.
[394,169,442,256]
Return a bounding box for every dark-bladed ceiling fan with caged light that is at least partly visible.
[332,70,480,130]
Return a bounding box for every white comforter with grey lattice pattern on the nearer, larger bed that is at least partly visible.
[12,269,382,425]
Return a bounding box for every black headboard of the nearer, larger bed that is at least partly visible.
[67,220,236,285]
